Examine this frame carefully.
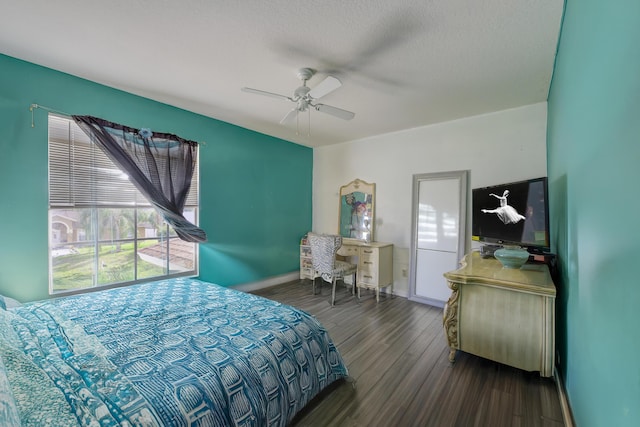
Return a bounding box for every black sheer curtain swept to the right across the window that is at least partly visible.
[72,116,207,242]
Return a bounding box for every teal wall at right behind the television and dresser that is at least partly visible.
[547,0,640,427]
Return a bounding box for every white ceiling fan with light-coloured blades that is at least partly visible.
[242,68,355,124]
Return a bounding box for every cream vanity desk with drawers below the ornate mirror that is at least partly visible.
[338,239,393,302]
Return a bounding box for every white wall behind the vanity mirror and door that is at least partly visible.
[313,102,547,296]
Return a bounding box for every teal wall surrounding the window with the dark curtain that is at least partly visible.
[0,55,313,301]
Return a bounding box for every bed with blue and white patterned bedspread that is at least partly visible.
[0,278,348,427]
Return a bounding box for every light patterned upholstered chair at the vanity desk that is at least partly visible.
[307,233,358,305]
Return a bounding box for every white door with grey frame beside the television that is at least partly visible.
[409,171,468,307]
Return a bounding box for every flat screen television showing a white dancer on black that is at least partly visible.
[471,177,549,253]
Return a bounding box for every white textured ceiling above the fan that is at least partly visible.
[0,0,563,147]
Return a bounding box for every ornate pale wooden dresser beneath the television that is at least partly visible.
[443,252,556,377]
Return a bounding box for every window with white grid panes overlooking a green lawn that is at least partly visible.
[49,114,199,294]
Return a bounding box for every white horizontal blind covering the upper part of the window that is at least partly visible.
[49,114,199,208]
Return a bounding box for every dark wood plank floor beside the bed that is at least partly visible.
[254,281,563,427]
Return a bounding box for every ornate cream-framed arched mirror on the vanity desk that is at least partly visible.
[338,178,376,242]
